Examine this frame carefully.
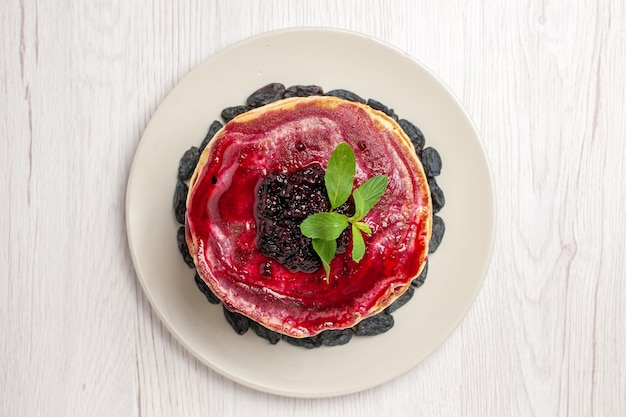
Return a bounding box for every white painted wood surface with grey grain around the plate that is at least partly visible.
[0,0,626,417]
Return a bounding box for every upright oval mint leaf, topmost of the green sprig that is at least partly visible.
[324,142,356,210]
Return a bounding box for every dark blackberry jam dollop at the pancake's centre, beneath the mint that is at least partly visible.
[255,163,354,272]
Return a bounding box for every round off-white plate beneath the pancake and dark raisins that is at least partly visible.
[126,29,495,397]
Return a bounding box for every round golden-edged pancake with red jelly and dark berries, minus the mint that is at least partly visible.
[185,96,432,338]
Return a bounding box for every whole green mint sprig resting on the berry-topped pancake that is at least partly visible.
[300,142,389,282]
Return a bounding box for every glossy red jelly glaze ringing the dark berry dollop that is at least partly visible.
[187,100,431,337]
